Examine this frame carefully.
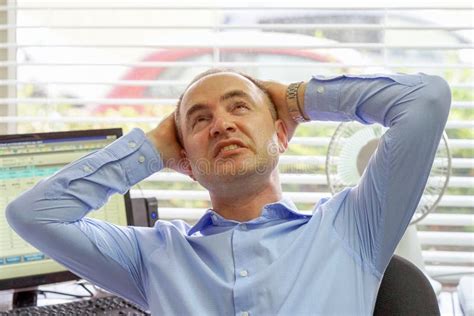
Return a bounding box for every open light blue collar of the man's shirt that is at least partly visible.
[188,196,311,236]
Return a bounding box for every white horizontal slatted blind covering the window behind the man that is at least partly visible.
[0,0,474,285]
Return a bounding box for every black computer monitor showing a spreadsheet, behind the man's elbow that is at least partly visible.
[0,128,132,306]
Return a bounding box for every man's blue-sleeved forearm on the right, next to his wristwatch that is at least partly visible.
[299,74,450,126]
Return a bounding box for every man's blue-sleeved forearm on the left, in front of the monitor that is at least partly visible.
[7,129,162,228]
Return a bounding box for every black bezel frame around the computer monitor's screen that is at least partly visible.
[0,128,133,291]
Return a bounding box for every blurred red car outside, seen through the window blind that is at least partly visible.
[94,32,361,115]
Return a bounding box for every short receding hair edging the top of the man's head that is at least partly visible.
[174,68,278,145]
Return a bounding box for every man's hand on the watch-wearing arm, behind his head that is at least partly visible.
[260,81,306,141]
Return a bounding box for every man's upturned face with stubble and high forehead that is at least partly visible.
[179,72,287,190]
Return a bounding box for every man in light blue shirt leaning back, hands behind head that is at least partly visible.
[7,70,451,315]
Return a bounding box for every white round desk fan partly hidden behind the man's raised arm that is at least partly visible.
[326,122,451,294]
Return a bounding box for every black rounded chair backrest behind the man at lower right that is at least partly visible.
[374,255,440,316]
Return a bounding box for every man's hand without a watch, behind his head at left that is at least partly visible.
[146,111,190,175]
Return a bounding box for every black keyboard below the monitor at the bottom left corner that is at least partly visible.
[0,296,150,316]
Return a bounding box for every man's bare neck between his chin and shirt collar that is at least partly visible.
[209,171,282,222]
